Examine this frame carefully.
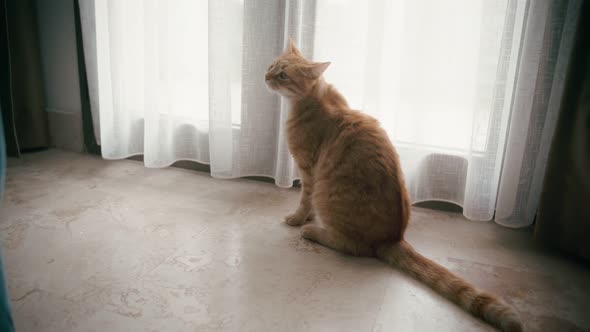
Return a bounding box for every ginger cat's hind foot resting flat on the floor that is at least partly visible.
[301,224,374,256]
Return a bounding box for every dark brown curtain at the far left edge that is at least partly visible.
[0,0,49,157]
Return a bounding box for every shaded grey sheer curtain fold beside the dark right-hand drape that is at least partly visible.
[495,0,582,227]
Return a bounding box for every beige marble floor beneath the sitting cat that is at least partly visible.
[0,150,590,332]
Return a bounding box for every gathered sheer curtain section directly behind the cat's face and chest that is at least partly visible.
[209,0,314,187]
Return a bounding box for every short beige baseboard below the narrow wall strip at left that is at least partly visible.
[46,108,84,152]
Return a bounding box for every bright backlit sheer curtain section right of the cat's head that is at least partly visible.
[314,0,525,220]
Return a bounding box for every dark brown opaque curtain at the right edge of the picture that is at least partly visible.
[535,2,590,261]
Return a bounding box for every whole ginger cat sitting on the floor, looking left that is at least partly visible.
[265,40,522,331]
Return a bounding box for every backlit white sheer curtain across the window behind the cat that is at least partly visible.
[81,0,584,225]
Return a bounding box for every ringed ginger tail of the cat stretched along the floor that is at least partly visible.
[377,240,522,332]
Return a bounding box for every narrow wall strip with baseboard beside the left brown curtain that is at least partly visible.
[36,0,84,151]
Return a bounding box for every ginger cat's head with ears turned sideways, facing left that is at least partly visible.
[264,39,330,97]
